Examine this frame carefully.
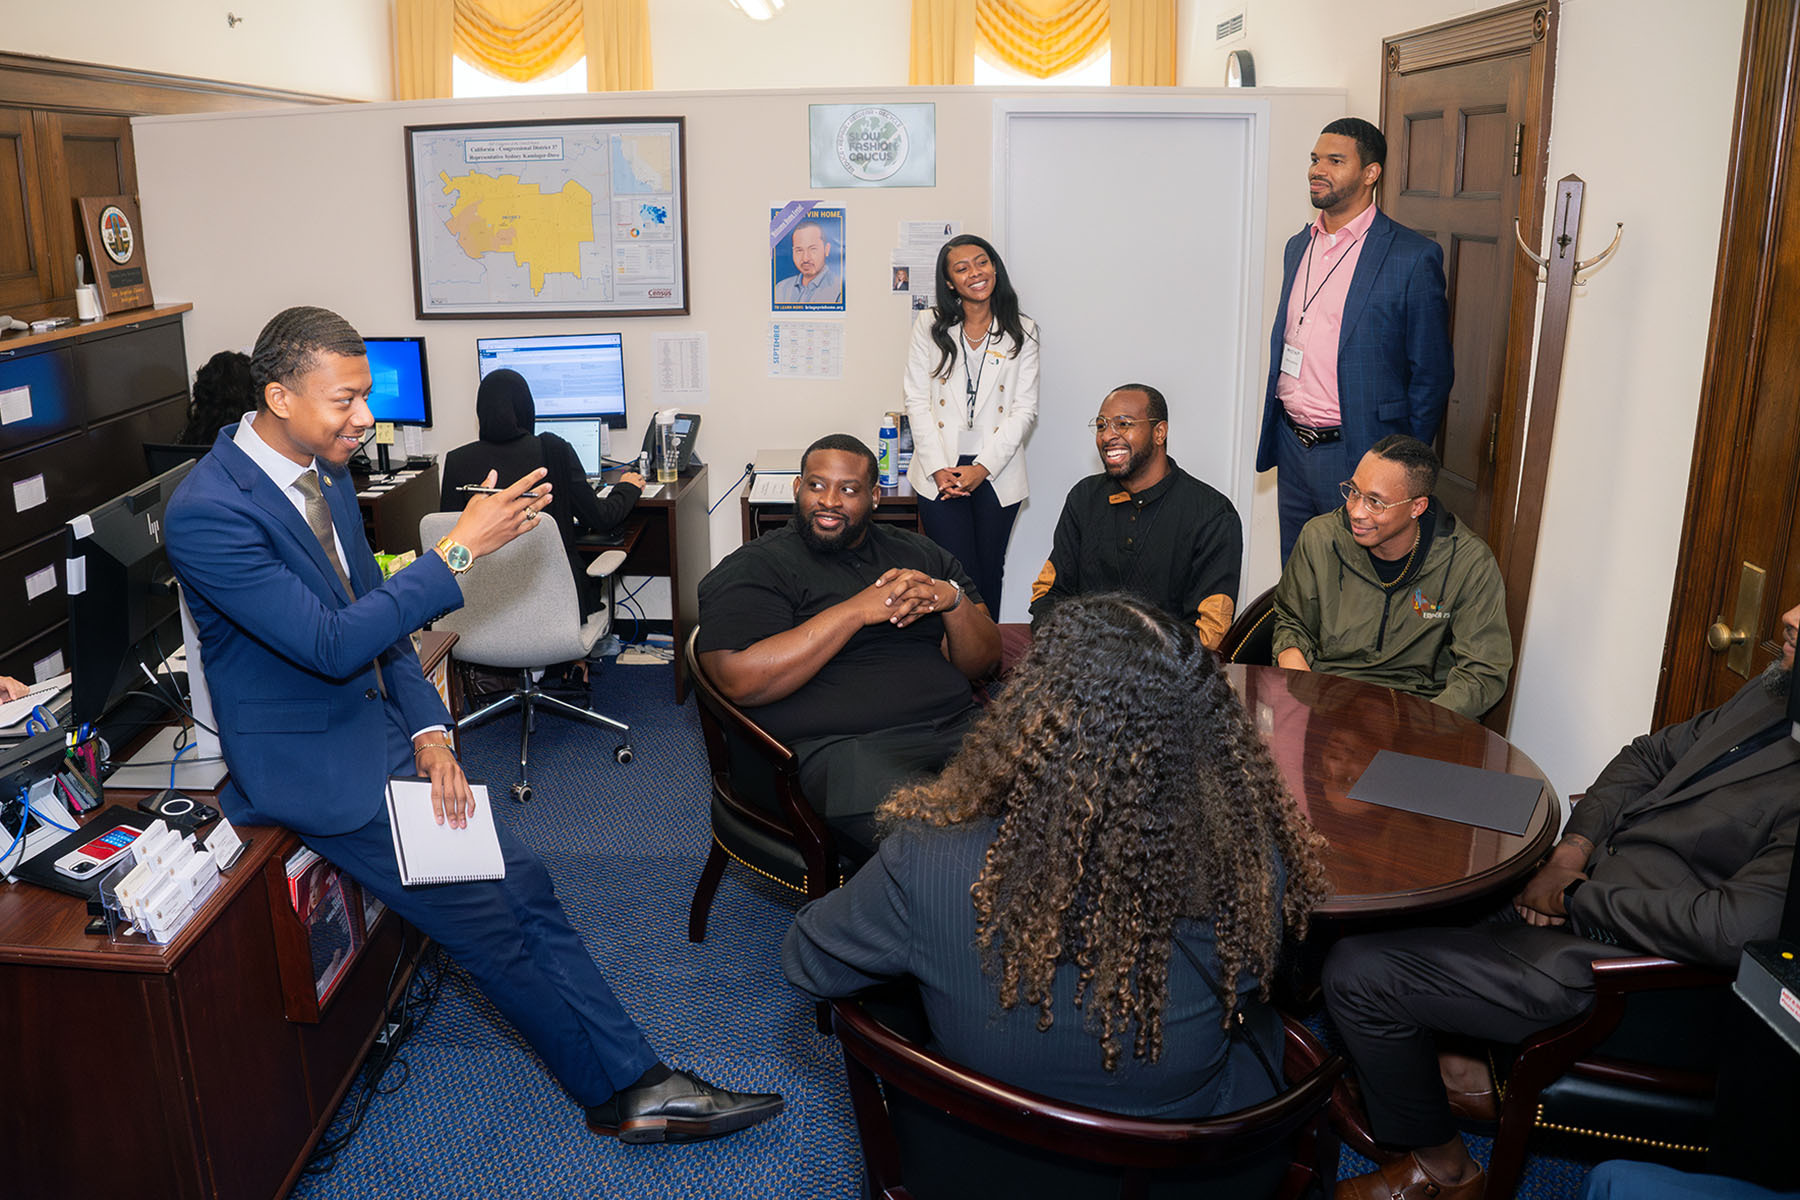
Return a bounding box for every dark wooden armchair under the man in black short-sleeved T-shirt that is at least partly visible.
[682,626,853,941]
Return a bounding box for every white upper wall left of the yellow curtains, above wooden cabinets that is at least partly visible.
[0,0,394,99]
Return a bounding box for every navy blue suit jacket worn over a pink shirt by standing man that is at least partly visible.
[1256,212,1456,471]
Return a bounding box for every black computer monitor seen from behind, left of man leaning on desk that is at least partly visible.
[65,462,225,788]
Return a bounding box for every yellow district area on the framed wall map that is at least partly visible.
[437,171,594,295]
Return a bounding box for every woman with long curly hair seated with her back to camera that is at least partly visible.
[783,592,1327,1117]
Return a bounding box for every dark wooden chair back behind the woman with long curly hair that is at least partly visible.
[832,1000,1345,1200]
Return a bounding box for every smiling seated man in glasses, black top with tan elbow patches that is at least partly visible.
[1031,383,1244,648]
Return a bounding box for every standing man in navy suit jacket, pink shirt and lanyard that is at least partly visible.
[1256,117,1454,563]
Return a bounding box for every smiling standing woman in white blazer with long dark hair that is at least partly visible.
[905,234,1037,619]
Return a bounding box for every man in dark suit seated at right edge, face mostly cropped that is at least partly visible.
[1325,608,1800,1200]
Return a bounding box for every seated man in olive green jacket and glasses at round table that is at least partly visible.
[1273,434,1512,718]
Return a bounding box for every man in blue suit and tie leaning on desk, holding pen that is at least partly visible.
[166,308,781,1142]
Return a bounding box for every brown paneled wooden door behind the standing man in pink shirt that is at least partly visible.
[1381,4,1553,536]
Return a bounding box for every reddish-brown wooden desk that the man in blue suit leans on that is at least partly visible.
[0,631,455,1200]
